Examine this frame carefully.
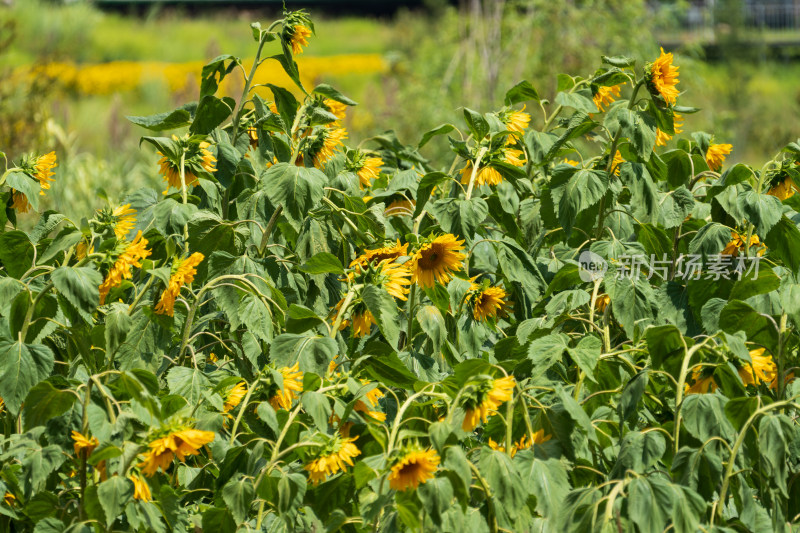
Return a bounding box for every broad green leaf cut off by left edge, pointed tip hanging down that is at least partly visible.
[0,339,54,416]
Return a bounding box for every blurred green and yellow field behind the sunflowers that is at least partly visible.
[0,0,800,218]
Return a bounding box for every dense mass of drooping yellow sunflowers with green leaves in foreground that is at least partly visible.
[0,11,800,533]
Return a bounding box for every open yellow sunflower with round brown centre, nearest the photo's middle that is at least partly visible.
[408,233,467,289]
